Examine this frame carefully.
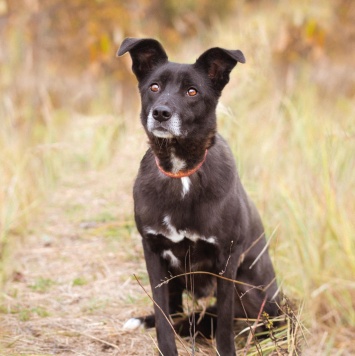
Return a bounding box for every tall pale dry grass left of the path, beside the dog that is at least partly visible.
[0,23,124,287]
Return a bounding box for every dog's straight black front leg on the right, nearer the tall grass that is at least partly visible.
[216,252,237,356]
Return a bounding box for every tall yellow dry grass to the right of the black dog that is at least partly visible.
[200,5,355,354]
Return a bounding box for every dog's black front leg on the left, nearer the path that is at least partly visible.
[143,237,178,356]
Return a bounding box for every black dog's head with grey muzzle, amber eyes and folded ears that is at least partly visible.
[118,38,245,139]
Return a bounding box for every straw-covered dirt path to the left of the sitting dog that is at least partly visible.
[0,119,165,355]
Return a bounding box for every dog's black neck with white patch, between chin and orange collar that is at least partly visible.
[150,135,215,178]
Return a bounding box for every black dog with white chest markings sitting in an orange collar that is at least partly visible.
[118,38,278,356]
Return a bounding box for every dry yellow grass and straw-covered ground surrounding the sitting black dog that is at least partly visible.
[0,1,355,356]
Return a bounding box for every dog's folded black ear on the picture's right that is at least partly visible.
[195,47,245,91]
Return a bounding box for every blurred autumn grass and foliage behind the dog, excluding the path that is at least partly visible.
[0,0,355,355]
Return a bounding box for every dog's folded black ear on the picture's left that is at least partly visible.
[117,38,168,81]
